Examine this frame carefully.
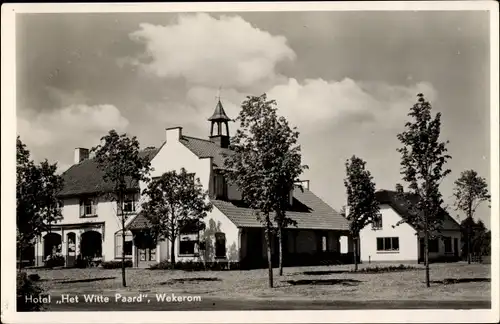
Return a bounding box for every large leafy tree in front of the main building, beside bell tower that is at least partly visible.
[224,94,307,287]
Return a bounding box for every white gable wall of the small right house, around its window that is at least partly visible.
[360,204,418,262]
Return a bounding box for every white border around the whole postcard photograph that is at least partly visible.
[1,1,500,323]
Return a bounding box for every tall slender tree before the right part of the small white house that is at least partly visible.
[397,93,451,287]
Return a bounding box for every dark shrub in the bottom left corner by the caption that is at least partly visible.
[16,272,46,312]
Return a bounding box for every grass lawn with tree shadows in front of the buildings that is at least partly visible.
[23,263,491,301]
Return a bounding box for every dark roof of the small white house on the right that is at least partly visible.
[375,190,460,231]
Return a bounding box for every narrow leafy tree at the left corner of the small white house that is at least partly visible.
[344,155,380,271]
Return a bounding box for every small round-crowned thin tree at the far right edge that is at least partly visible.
[453,170,491,264]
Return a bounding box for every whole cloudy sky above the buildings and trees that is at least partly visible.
[16,11,490,226]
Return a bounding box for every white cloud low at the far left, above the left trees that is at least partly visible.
[17,104,129,167]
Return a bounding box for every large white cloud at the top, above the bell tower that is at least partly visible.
[127,13,295,88]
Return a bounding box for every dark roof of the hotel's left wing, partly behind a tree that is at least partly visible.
[58,148,159,197]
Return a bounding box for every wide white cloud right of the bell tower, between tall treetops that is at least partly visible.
[268,78,436,129]
